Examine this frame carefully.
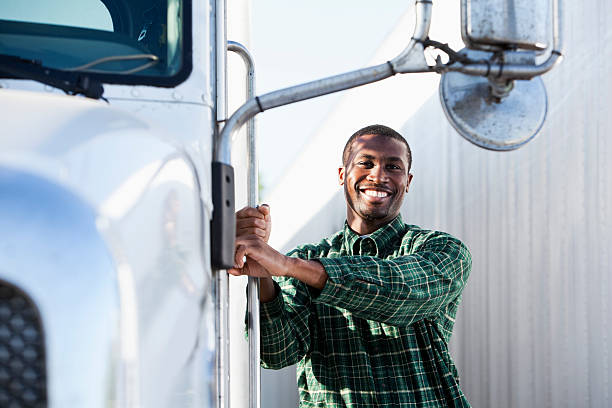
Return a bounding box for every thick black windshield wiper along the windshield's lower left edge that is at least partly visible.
[0,54,104,99]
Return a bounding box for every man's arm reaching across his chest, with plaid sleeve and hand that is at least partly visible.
[234,228,471,326]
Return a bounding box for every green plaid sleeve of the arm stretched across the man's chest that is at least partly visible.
[313,233,472,326]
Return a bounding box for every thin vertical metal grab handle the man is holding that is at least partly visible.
[227,41,261,408]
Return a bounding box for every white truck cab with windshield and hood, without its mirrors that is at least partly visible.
[0,0,216,407]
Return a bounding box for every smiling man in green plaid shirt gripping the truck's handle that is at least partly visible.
[230,125,471,408]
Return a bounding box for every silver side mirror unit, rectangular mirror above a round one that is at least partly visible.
[440,0,561,151]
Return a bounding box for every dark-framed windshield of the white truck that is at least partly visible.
[0,0,191,86]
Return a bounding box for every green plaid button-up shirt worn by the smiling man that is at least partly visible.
[261,216,472,408]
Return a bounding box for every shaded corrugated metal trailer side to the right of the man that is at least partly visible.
[402,0,612,407]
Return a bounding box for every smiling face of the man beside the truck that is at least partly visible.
[339,135,412,233]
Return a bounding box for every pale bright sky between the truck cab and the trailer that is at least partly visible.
[251,0,414,198]
